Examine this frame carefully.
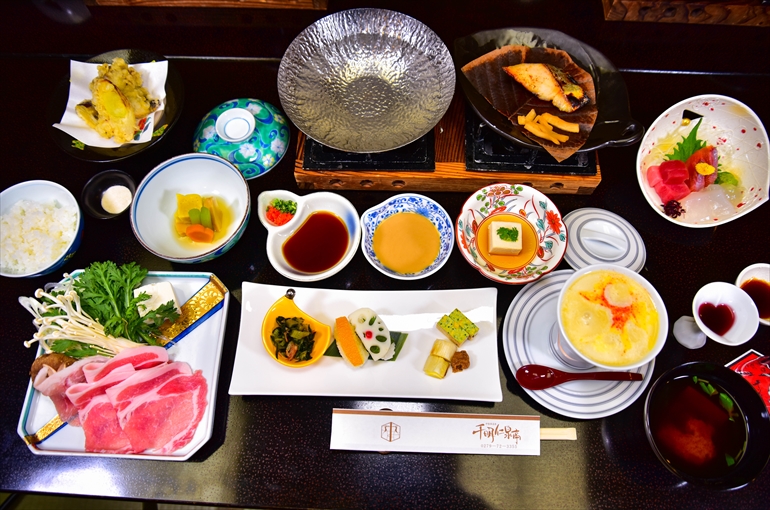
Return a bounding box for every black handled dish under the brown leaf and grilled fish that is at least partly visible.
[454,28,644,152]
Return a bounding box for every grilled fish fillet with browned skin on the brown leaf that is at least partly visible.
[503,64,589,112]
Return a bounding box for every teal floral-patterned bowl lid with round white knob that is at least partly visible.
[193,98,290,179]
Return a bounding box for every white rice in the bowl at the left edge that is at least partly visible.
[0,200,78,274]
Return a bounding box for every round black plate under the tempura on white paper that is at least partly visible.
[46,49,184,163]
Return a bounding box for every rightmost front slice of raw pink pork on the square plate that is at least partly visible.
[107,362,208,454]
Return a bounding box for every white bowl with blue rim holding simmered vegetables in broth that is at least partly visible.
[131,153,251,264]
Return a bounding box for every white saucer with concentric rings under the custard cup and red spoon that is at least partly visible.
[503,269,655,419]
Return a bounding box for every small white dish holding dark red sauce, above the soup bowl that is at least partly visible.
[692,282,759,345]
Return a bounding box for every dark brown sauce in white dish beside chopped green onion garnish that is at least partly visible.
[283,211,350,273]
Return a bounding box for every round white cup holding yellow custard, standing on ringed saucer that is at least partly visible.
[556,264,668,370]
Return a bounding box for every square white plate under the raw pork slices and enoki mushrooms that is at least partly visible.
[17,271,230,461]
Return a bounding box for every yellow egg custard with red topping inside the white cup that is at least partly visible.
[559,270,659,366]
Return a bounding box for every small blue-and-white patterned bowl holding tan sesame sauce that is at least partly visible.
[361,193,455,280]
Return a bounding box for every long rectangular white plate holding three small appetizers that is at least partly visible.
[230,282,503,402]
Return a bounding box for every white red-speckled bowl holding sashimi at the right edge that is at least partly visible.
[636,94,770,228]
